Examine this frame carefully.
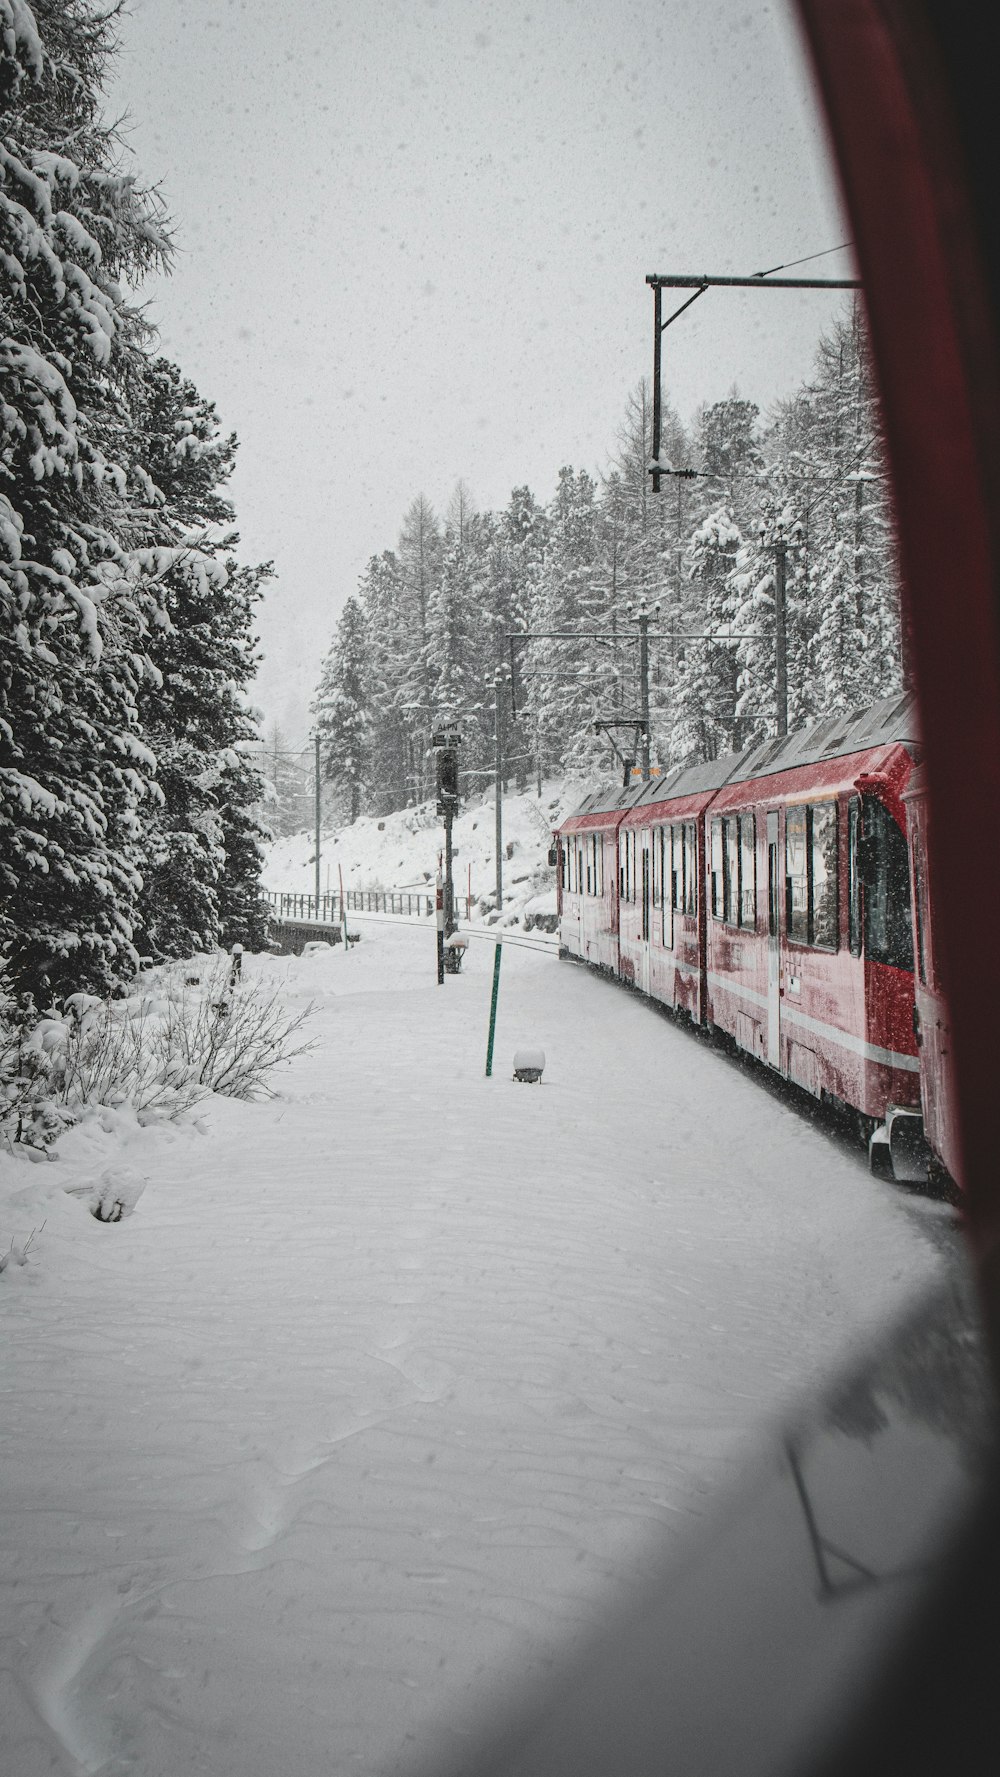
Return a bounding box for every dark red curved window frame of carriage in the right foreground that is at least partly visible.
[798,0,1000,1307]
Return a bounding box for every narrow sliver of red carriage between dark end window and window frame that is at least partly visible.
[902,766,961,1187]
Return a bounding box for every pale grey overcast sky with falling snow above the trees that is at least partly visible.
[112,0,851,737]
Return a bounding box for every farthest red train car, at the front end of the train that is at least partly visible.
[554,780,647,976]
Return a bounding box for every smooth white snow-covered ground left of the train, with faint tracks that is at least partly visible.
[0,920,954,1777]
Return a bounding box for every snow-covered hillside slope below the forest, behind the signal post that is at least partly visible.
[265,778,591,924]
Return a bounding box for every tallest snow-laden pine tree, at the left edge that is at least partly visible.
[0,0,169,999]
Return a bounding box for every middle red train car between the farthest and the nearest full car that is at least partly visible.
[618,759,735,1024]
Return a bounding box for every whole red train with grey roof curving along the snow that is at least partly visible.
[556,697,957,1182]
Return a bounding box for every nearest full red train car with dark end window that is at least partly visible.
[705,697,920,1139]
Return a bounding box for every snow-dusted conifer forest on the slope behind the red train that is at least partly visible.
[313,325,904,817]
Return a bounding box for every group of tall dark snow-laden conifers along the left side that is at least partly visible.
[0,0,268,1004]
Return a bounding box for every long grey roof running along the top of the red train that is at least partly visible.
[561,691,920,826]
